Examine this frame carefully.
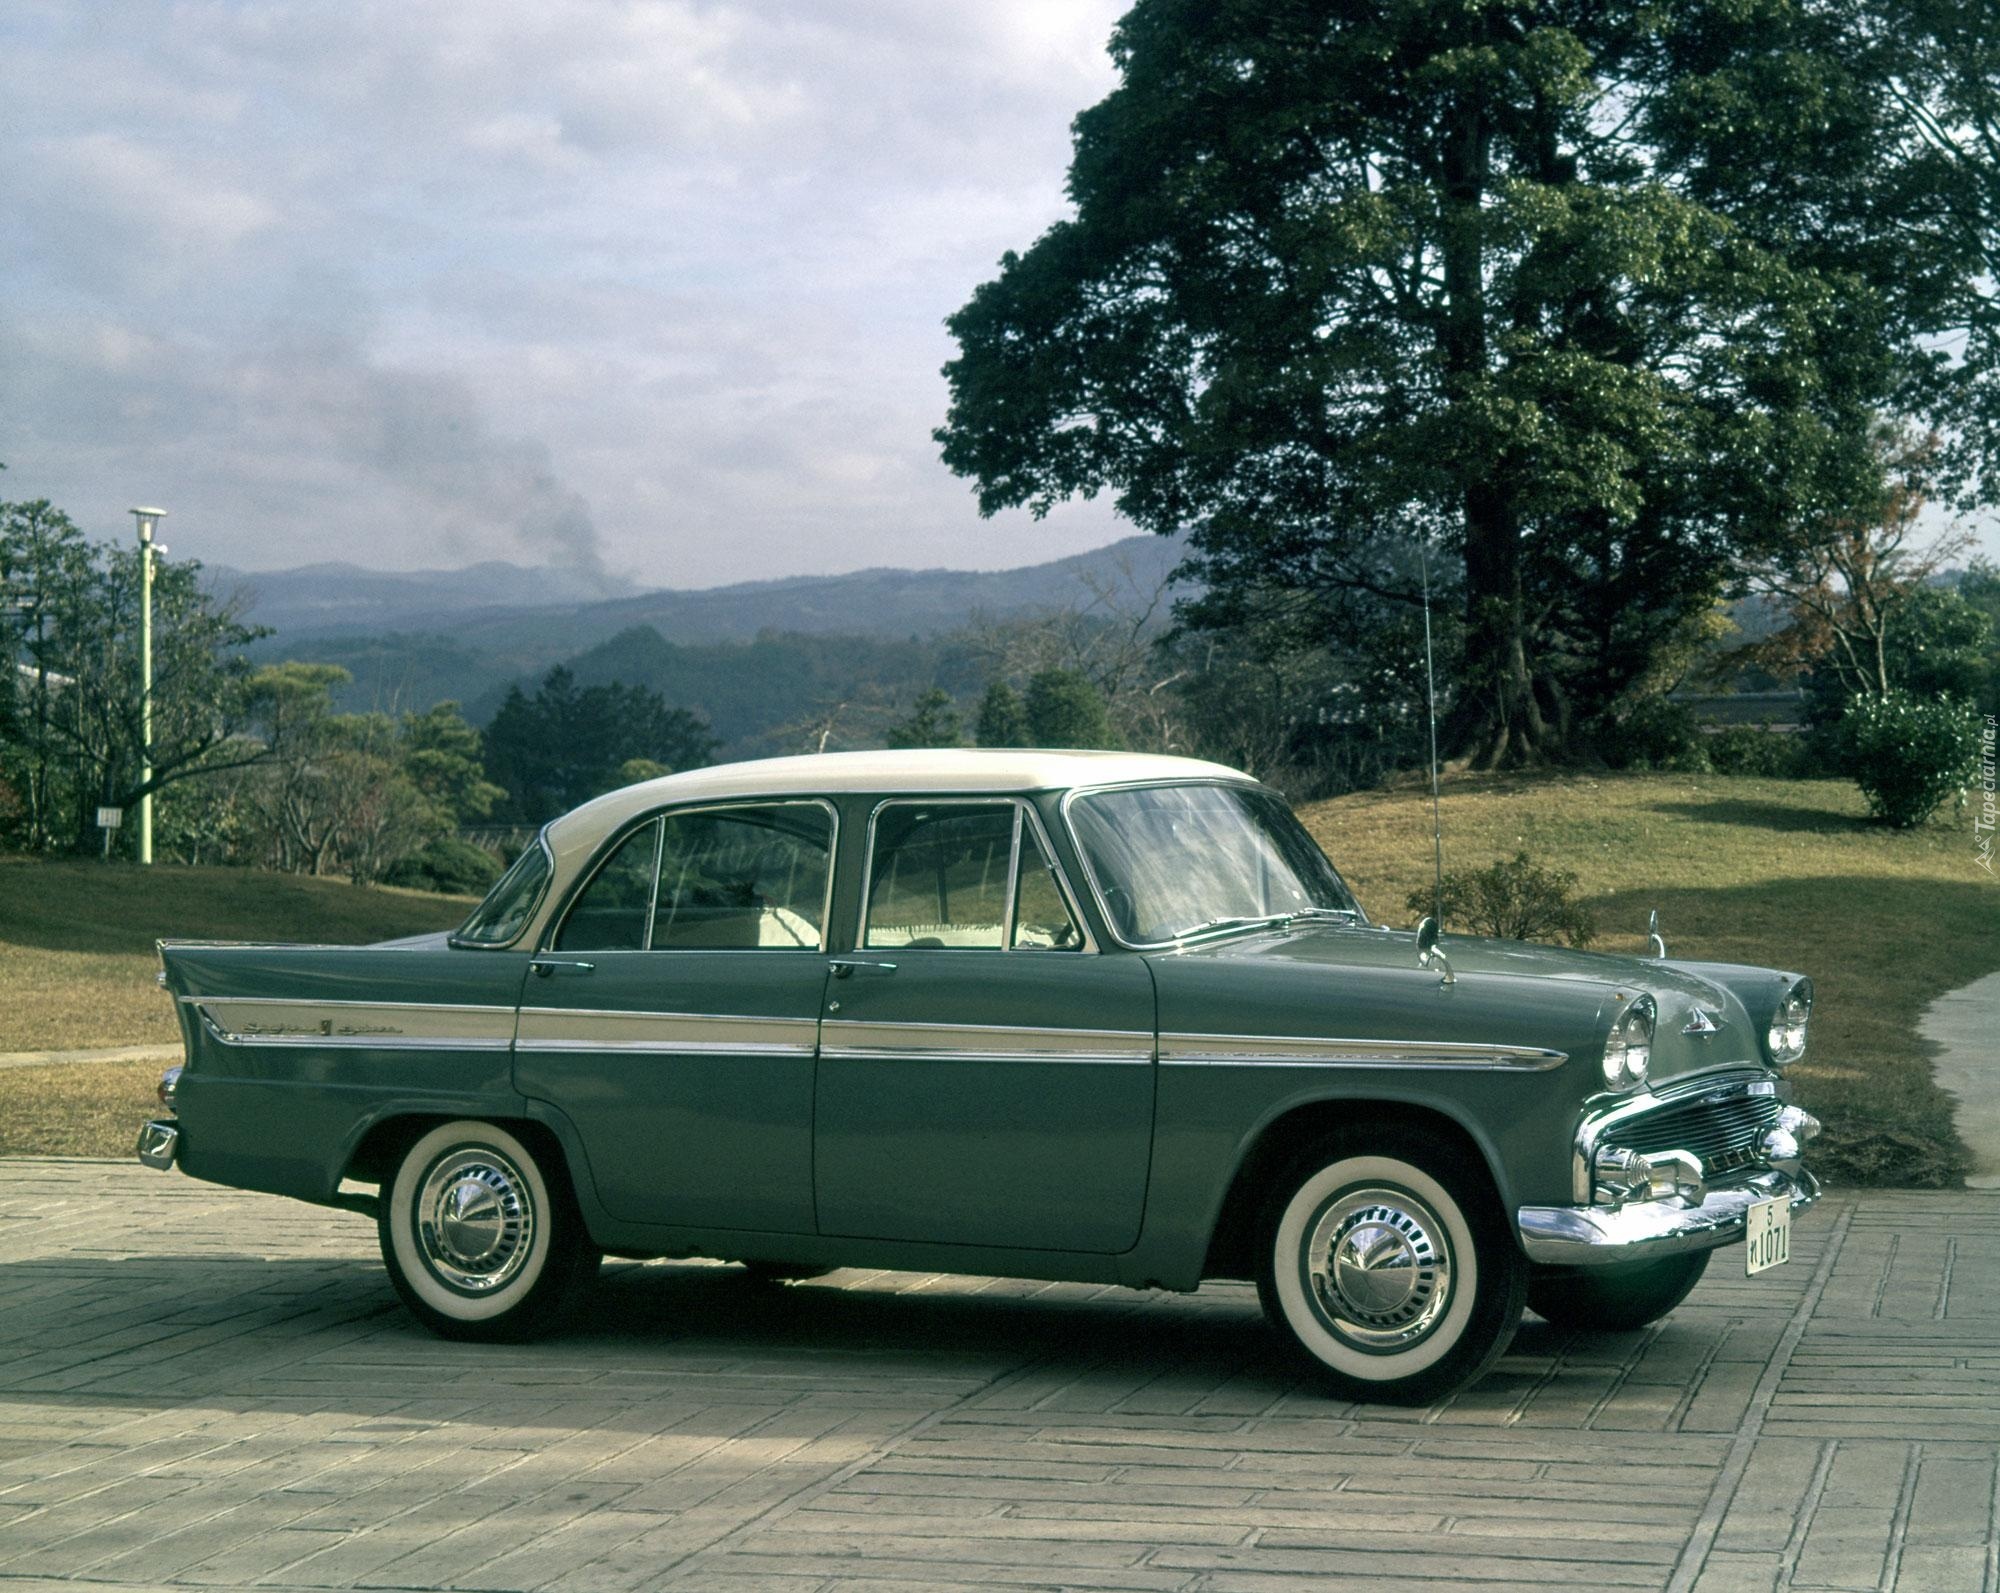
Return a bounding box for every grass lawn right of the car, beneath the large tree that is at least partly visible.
[1304,774,2000,1187]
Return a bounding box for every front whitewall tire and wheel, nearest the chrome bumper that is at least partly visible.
[1258,1129,1526,1405]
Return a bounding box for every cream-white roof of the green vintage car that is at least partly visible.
[532,746,1250,869]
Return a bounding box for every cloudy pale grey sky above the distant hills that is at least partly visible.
[0,0,1130,586]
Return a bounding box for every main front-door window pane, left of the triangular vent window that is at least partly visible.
[862,803,1018,951]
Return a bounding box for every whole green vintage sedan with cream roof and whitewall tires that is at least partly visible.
[138,750,1818,1401]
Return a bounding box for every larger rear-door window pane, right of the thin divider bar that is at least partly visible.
[652,803,834,951]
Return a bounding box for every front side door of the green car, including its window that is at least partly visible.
[814,799,1154,1253]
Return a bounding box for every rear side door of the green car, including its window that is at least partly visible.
[514,801,836,1233]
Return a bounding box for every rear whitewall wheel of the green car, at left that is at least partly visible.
[376,1121,602,1341]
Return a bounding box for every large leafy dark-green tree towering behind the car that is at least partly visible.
[938,0,1992,764]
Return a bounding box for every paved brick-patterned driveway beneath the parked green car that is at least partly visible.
[0,1161,2000,1593]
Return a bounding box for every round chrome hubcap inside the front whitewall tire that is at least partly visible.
[1306,1189,1452,1351]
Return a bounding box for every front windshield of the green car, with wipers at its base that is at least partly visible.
[1070,784,1362,945]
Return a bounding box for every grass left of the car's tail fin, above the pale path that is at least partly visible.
[0,859,470,1051]
